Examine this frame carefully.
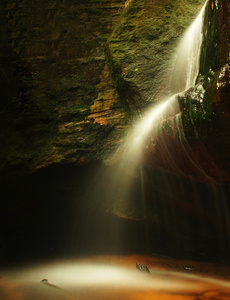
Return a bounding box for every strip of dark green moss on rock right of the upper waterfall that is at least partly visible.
[184,0,228,130]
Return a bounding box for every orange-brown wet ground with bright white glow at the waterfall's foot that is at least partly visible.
[0,256,230,300]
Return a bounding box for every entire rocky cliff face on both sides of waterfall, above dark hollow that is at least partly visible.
[0,0,230,181]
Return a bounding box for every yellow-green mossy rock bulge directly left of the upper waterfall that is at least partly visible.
[107,0,203,110]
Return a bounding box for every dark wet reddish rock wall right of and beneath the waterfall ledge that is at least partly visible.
[122,0,230,183]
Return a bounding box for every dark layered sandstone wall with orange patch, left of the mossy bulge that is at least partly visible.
[0,0,127,170]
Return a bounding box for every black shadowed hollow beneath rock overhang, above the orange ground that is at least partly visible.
[0,162,230,264]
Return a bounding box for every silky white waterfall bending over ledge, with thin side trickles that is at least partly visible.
[100,1,211,227]
